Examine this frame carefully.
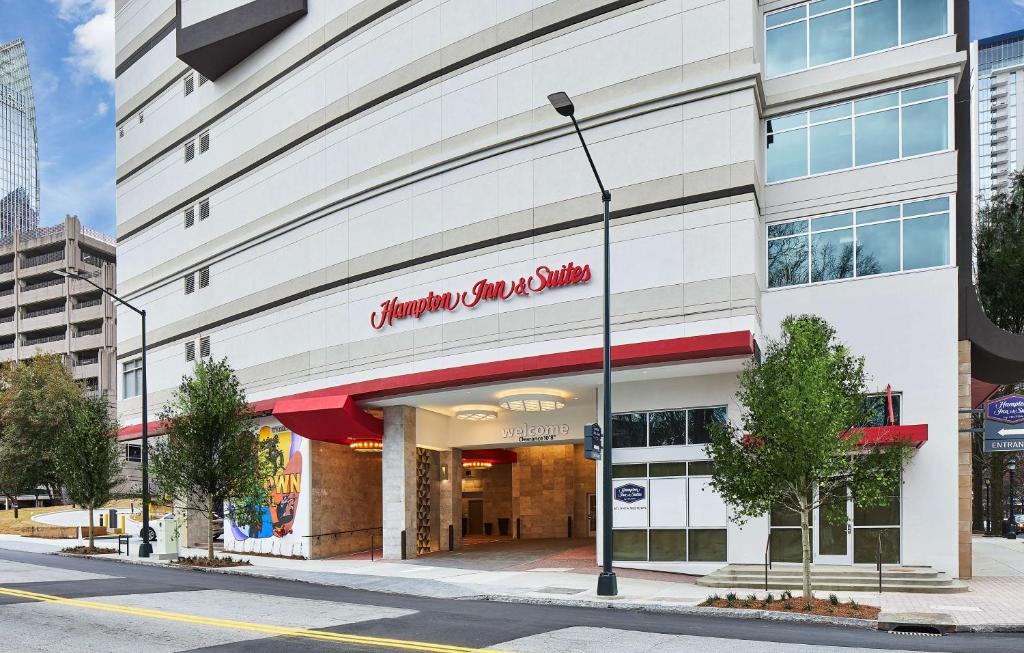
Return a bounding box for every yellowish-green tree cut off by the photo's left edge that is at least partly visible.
[0,354,81,518]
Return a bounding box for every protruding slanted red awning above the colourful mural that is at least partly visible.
[273,394,383,444]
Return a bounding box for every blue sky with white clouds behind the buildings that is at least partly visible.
[0,0,1024,240]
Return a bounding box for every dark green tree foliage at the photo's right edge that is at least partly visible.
[975,171,1024,334]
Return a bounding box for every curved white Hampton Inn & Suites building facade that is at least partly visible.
[117,0,970,575]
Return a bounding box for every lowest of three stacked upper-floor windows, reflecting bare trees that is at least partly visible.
[770,197,951,286]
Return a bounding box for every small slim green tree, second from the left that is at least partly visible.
[56,396,121,549]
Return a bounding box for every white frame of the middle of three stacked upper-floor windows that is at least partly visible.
[762,78,955,186]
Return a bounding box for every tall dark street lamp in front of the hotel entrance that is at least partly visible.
[548,91,618,597]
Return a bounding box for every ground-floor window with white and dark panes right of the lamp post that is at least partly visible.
[612,460,727,562]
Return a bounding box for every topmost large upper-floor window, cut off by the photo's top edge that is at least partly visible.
[765,0,948,77]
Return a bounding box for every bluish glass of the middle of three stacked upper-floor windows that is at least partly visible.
[765,82,949,183]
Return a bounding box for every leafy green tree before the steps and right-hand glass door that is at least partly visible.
[708,315,910,600]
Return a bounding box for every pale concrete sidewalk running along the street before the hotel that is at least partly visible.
[0,535,1024,632]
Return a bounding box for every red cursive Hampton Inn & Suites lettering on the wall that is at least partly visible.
[370,261,591,331]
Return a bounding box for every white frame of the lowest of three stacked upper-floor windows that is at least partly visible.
[763,194,956,293]
